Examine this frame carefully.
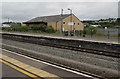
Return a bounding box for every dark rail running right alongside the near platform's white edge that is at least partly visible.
[2,47,106,79]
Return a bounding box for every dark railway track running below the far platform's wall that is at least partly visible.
[2,34,120,58]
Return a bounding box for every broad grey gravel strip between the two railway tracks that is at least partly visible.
[2,39,119,70]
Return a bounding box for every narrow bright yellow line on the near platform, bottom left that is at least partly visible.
[0,59,41,79]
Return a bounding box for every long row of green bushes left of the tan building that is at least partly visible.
[2,24,55,33]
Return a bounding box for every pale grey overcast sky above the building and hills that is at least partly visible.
[0,0,118,22]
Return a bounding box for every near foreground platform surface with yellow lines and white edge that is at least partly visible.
[1,50,91,79]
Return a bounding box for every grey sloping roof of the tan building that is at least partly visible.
[27,14,70,22]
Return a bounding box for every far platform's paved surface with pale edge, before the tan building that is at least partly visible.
[2,32,120,44]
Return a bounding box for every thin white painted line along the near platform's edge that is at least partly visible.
[0,48,95,79]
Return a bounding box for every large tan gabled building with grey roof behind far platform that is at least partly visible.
[22,14,84,31]
